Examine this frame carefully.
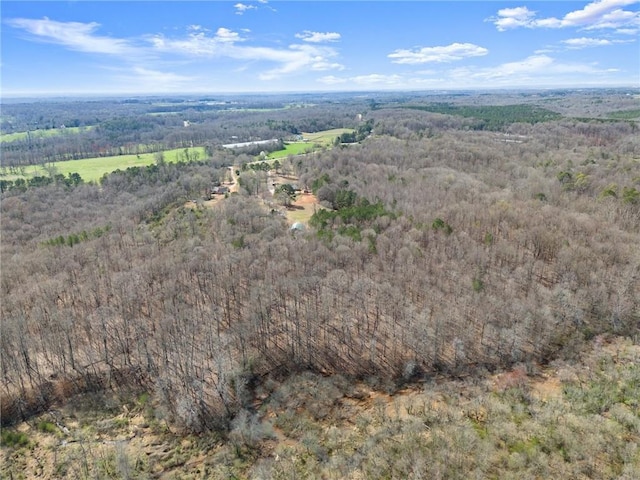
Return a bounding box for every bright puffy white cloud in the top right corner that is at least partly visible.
[488,0,640,33]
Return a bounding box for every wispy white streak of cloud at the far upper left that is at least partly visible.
[6,17,134,55]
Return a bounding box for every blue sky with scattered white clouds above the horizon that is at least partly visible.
[0,0,640,96]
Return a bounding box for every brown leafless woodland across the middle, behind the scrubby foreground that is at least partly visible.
[0,90,640,431]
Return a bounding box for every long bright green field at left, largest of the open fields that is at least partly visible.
[0,147,205,182]
